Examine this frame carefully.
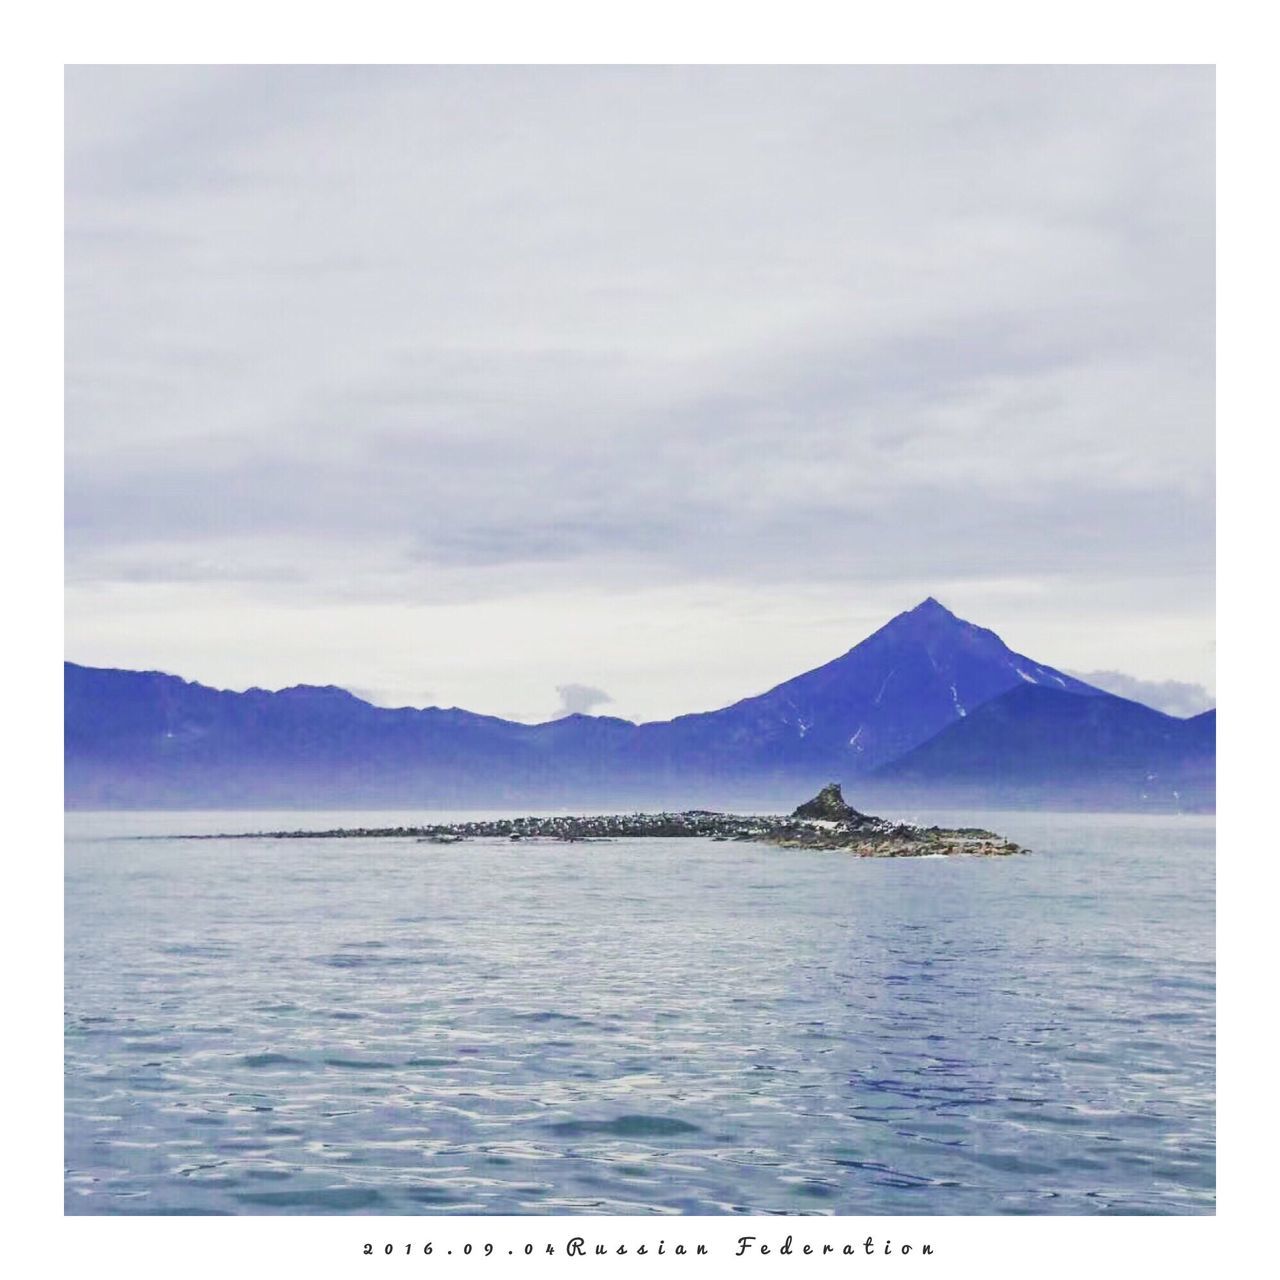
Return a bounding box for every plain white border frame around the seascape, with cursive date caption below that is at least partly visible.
[12,0,1280,1280]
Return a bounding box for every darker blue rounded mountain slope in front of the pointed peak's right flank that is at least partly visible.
[877,685,1217,809]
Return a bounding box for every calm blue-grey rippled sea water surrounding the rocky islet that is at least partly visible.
[65,813,1215,1215]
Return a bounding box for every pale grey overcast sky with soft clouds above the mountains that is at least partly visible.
[65,67,1215,721]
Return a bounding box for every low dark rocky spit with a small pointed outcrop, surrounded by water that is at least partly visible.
[189,782,1027,858]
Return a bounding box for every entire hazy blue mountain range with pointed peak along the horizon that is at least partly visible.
[65,598,1216,809]
